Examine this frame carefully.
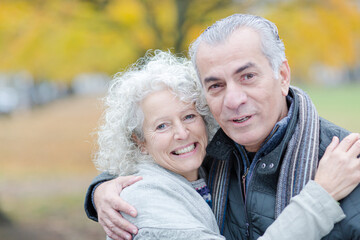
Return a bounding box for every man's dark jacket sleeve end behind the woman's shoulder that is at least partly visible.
[84,172,116,222]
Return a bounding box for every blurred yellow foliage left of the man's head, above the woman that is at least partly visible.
[0,0,242,82]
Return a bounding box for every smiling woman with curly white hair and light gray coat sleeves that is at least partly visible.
[95,51,358,239]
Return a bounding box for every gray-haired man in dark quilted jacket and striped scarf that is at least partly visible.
[85,14,360,239]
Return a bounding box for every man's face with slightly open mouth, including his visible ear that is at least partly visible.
[196,28,290,152]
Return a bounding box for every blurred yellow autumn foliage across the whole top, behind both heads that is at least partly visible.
[0,0,360,82]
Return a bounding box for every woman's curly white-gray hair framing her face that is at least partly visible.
[94,50,217,175]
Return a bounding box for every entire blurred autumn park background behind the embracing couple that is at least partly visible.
[0,0,360,240]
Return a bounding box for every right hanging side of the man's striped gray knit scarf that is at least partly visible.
[275,87,319,217]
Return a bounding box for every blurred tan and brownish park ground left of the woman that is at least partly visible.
[0,96,104,240]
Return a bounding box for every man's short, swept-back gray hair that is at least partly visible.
[189,14,286,78]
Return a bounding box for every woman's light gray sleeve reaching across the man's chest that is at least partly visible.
[258,181,345,240]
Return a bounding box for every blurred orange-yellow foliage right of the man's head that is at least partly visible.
[265,0,360,80]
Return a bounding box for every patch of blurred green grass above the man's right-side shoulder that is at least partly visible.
[301,83,360,132]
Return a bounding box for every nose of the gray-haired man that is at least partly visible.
[224,84,247,110]
